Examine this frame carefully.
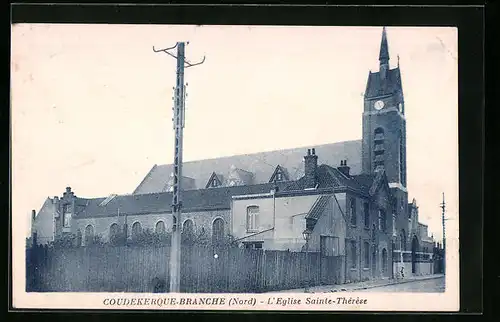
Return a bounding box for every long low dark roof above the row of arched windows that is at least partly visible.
[77,183,288,218]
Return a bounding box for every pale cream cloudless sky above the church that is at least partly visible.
[11,24,458,240]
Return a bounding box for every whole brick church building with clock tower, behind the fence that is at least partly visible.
[33,28,434,281]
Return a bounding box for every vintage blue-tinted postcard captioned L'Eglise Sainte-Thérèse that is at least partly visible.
[11,24,460,311]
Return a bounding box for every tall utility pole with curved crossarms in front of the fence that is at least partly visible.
[153,42,205,293]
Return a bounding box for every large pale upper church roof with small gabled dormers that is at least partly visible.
[134,140,361,194]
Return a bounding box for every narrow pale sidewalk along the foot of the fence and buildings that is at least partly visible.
[269,274,444,293]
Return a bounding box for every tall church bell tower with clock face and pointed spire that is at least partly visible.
[362,27,406,192]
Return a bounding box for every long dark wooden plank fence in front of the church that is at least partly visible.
[26,246,344,293]
